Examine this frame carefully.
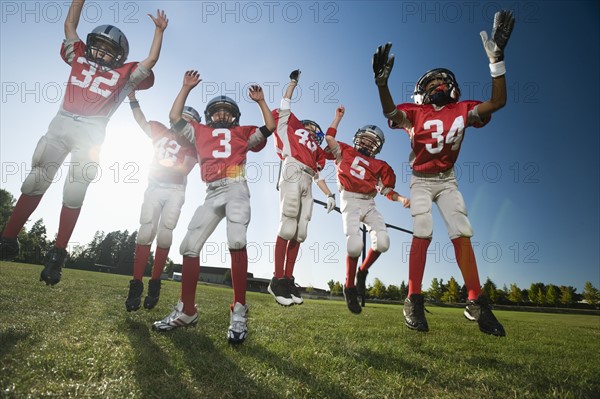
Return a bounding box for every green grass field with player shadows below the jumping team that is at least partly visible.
[0,262,600,399]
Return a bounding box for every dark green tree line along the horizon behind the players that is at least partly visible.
[0,189,600,307]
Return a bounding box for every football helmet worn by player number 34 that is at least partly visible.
[413,68,460,107]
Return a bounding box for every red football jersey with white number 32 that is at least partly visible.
[60,40,152,117]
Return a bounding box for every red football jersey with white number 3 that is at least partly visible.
[189,121,267,183]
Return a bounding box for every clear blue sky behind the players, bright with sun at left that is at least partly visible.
[0,1,600,292]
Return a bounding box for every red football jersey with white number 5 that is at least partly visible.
[336,141,396,195]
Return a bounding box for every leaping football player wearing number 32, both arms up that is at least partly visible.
[0,0,168,285]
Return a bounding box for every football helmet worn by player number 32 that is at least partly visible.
[85,25,129,69]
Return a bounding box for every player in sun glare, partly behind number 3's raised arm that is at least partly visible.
[125,91,201,312]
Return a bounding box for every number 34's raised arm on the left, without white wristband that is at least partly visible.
[373,43,405,125]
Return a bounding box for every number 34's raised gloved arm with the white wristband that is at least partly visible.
[477,10,515,120]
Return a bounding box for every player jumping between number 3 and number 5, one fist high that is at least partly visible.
[267,70,335,306]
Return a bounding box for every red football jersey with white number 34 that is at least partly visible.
[389,101,490,173]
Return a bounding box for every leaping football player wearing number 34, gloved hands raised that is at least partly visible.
[373,11,515,337]
